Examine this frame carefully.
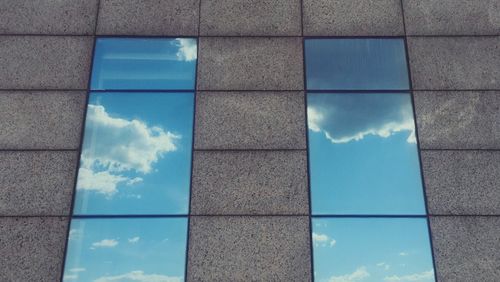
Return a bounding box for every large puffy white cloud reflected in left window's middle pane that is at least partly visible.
[77,104,181,197]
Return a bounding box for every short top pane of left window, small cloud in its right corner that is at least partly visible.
[91,38,196,90]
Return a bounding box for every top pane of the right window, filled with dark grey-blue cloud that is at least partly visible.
[305,39,409,90]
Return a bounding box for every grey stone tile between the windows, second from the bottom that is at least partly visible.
[191,150,309,215]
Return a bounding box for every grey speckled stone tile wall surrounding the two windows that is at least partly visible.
[0,0,500,281]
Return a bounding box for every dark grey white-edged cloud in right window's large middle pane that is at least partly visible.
[307,93,416,143]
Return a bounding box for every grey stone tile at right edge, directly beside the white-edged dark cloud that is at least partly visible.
[413,91,500,149]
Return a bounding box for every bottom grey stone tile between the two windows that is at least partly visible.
[187,216,311,282]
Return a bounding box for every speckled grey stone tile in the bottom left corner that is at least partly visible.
[0,217,68,282]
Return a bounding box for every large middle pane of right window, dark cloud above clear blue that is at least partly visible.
[307,93,425,214]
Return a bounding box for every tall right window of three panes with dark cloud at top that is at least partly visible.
[305,38,435,281]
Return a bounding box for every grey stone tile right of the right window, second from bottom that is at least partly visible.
[421,150,500,215]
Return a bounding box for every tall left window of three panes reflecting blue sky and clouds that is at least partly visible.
[63,38,197,281]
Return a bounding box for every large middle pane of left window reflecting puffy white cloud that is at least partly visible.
[74,92,194,214]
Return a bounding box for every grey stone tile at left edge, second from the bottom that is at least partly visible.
[0,151,78,216]
